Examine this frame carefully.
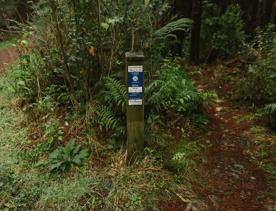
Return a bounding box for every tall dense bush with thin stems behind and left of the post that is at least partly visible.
[16,0,191,110]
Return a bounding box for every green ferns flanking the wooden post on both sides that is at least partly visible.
[88,62,212,142]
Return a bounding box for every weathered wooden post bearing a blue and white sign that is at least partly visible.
[125,52,144,164]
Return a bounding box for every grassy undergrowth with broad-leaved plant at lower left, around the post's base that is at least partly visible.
[0,67,198,210]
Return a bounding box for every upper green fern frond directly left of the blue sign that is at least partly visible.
[105,77,127,112]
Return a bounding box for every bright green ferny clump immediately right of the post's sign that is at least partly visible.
[145,63,208,114]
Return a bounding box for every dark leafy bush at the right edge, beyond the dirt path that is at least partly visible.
[237,26,276,104]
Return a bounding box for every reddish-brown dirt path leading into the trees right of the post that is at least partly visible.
[193,67,271,211]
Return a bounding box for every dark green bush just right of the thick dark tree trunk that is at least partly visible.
[202,4,246,58]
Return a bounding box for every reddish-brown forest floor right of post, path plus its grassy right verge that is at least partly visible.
[190,66,276,210]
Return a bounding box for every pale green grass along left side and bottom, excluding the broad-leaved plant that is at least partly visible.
[0,63,177,210]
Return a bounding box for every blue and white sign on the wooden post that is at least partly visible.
[128,66,143,105]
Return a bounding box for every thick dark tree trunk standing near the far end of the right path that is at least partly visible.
[190,0,202,65]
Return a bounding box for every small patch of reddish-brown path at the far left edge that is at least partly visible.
[0,46,18,75]
